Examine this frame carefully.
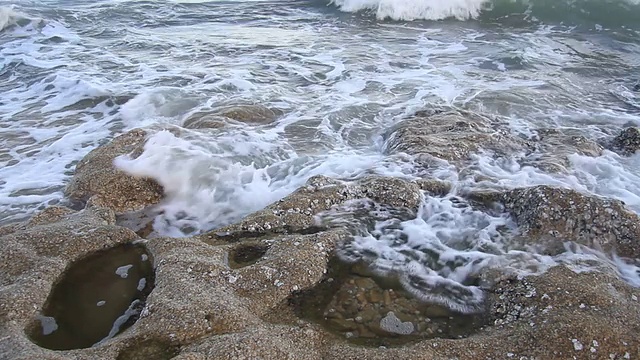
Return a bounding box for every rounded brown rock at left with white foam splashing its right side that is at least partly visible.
[65,129,163,213]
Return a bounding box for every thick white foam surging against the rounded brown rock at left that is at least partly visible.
[115,131,401,236]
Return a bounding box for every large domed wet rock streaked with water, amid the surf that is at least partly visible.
[386,111,524,164]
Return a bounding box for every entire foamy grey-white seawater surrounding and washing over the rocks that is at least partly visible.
[0,0,640,311]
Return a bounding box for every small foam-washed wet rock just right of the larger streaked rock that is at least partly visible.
[521,129,604,173]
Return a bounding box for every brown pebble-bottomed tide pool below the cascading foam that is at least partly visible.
[287,257,488,347]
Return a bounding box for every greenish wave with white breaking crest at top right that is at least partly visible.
[329,0,640,24]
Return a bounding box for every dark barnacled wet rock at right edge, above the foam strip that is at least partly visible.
[500,186,640,258]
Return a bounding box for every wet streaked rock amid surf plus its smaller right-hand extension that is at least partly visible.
[385,110,608,173]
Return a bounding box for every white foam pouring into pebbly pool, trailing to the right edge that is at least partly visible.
[332,191,640,313]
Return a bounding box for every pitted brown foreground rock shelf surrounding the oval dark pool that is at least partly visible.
[0,177,640,360]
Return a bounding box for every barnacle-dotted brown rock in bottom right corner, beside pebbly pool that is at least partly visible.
[325,266,640,360]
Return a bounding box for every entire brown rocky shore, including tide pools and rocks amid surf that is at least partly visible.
[0,108,640,360]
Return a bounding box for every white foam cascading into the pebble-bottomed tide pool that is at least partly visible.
[329,196,515,313]
